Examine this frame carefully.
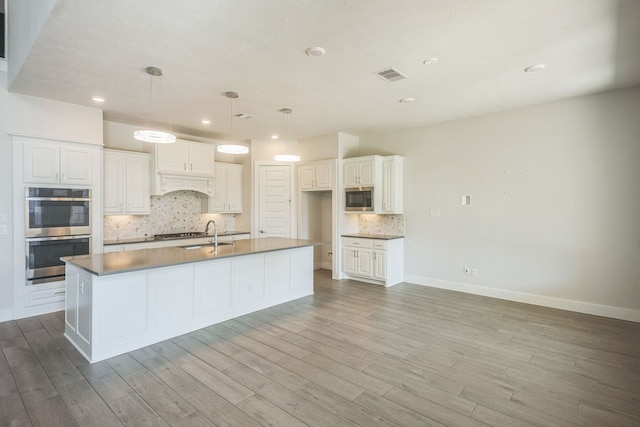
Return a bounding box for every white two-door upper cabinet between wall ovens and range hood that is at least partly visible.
[103,150,151,215]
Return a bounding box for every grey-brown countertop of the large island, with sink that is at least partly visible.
[62,237,322,276]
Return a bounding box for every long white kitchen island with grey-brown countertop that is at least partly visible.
[63,237,320,363]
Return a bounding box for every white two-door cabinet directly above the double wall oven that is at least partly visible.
[24,141,97,185]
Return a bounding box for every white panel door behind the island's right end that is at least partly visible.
[257,165,292,237]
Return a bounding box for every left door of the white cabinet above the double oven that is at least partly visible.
[24,142,60,184]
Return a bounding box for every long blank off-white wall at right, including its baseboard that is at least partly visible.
[360,87,640,321]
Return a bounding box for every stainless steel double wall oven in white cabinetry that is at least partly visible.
[25,187,91,285]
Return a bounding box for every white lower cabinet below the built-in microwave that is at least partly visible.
[342,237,404,286]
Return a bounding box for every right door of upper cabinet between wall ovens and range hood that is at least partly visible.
[125,155,151,214]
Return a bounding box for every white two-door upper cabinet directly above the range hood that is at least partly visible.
[154,140,216,178]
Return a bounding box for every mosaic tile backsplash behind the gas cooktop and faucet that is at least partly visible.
[104,191,235,240]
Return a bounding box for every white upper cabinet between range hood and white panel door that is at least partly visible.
[202,162,243,213]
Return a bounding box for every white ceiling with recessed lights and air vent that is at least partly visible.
[8,0,640,144]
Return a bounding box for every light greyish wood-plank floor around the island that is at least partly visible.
[0,270,640,427]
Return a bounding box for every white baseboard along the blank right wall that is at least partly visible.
[404,274,640,322]
